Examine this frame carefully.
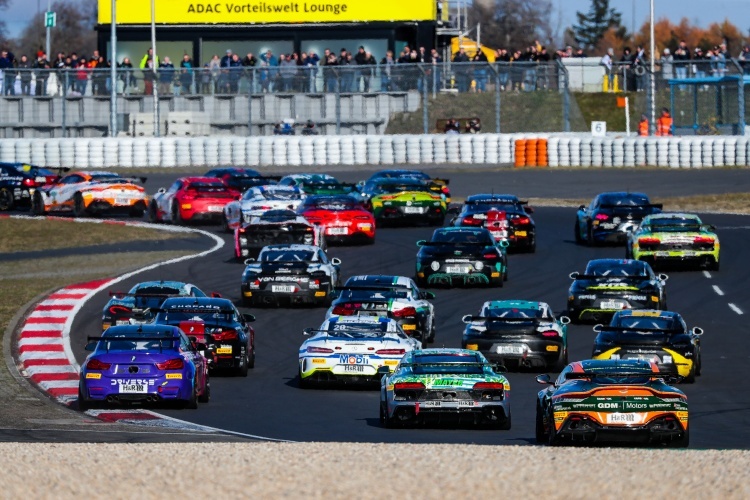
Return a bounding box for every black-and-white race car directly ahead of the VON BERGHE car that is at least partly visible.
[234,210,327,259]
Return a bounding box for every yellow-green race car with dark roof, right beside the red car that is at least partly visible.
[357,178,447,226]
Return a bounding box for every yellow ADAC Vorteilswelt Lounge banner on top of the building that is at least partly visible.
[99,0,437,25]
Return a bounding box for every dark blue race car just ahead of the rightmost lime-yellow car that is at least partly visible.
[575,192,662,245]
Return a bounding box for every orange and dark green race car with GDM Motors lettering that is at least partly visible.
[536,359,690,448]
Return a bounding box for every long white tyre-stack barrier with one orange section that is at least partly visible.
[0,134,750,169]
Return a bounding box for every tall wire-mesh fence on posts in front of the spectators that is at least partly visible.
[0,58,750,137]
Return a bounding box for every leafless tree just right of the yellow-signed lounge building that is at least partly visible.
[469,0,554,49]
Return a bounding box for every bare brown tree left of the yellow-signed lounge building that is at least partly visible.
[12,0,97,58]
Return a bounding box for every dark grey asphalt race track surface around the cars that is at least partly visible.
[71,169,750,448]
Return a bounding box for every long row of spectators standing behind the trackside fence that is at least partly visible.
[0,41,750,96]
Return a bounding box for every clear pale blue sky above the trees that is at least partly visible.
[2,0,750,40]
